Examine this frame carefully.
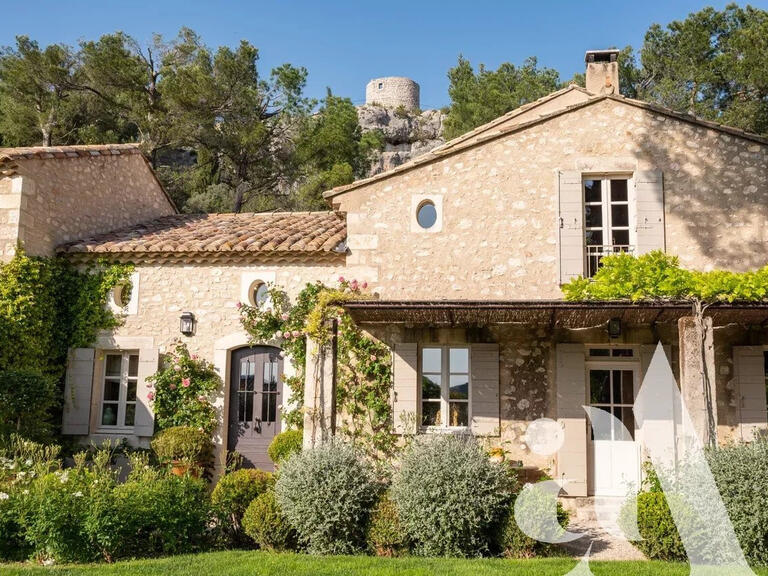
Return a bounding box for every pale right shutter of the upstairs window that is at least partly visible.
[635,170,665,255]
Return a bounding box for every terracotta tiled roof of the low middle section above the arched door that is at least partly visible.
[58,212,347,259]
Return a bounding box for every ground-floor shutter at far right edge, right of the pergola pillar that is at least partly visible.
[733,346,768,442]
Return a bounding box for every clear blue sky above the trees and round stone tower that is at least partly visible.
[0,0,768,108]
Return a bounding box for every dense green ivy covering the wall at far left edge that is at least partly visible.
[0,249,131,438]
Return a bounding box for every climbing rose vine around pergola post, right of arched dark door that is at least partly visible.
[240,277,395,457]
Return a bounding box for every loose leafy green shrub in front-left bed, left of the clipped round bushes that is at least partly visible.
[85,456,209,562]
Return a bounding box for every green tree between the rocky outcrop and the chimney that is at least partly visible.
[445,56,559,138]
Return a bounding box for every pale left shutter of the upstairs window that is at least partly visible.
[558,171,584,284]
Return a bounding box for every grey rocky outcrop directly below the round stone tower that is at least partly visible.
[357,104,445,175]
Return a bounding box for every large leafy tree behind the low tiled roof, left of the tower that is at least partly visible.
[163,41,312,212]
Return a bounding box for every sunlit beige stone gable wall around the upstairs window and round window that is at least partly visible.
[333,100,768,299]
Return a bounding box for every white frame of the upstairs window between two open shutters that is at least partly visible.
[581,172,637,275]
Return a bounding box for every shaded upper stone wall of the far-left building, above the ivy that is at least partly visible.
[0,154,175,259]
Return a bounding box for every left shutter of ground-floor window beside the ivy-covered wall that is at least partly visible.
[61,348,95,436]
